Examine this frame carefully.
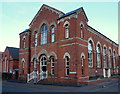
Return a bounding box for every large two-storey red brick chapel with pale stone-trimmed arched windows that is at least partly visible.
[19,4,118,84]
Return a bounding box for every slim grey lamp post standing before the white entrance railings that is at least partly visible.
[33,42,37,84]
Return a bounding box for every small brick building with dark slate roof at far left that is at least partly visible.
[2,47,19,79]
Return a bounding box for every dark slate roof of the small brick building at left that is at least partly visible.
[7,47,19,60]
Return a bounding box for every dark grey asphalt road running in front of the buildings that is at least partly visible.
[2,79,119,92]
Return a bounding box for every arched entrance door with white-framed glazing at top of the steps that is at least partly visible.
[40,56,47,79]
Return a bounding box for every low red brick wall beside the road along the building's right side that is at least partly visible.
[78,78,112,85]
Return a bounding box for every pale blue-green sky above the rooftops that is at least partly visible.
[0,0,118,51]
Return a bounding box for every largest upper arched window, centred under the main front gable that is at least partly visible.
[41,25,48,44]
